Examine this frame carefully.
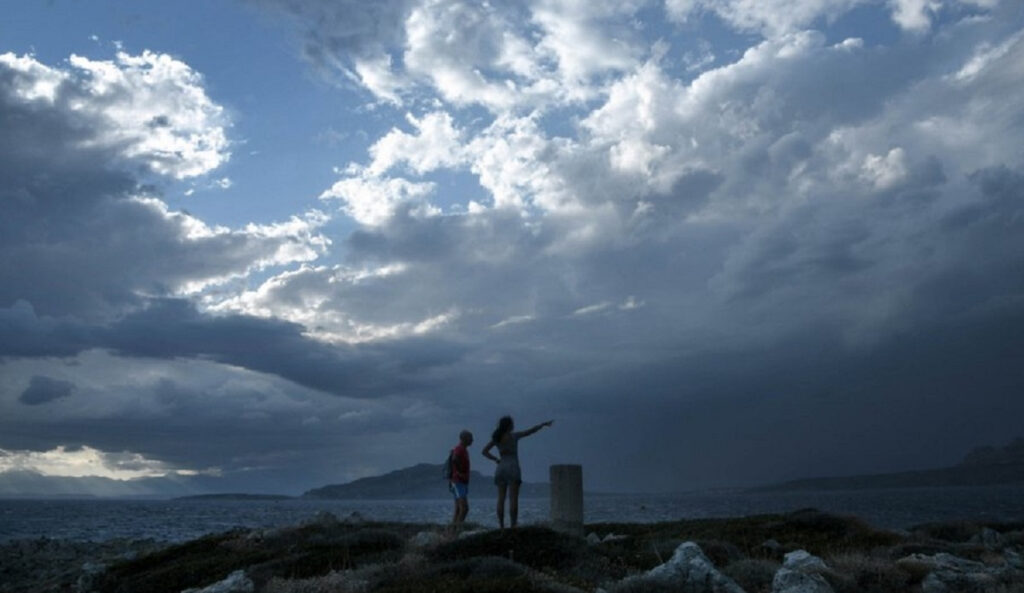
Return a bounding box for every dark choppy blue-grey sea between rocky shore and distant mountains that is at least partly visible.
[0,484,1024,543]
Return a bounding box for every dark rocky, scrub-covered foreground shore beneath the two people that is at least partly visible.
[0,510,1024,593]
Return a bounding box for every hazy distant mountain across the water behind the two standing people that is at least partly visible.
[302,463,549,500]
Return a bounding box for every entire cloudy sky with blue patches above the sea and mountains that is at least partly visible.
[0,0,1024,494]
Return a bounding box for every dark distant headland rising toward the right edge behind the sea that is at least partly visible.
[753,438,1024,492]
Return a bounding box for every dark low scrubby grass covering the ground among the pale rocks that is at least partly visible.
[86,509,1024,593]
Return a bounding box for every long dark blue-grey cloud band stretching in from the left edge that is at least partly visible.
[0,299,463,397]
